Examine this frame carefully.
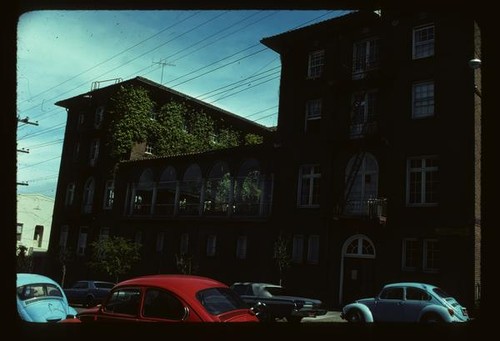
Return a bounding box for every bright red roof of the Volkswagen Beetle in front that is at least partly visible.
[116,274,227,293]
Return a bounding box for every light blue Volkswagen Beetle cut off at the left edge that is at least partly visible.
[16,273,77,323]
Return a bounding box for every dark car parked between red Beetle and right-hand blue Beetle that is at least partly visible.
[230,282,327,323]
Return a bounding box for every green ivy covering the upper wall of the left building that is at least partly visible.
[108,86,263,159]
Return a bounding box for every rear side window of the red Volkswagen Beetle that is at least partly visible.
[142,289,186,320]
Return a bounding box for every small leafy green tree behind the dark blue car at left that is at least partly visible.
[89,236,141,282]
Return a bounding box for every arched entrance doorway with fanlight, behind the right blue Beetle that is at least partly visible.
[339,234,375,304]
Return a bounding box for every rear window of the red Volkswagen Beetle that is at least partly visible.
[196,288,247,315]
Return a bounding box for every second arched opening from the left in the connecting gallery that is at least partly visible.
[155,166,177,215]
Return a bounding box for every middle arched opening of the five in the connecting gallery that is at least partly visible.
[179,163,202,215]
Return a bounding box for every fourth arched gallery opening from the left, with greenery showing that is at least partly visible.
[203,162,232,215]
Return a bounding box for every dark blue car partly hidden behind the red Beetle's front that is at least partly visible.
[63,280,115,307]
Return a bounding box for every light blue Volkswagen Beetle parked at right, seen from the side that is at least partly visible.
[341,282,469,323]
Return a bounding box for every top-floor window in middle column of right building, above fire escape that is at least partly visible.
[352,38,380,77]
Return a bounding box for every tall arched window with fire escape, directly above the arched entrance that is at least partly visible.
[344,153,378,215]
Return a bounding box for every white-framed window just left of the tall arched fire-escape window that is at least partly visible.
[298,164,321,207]
